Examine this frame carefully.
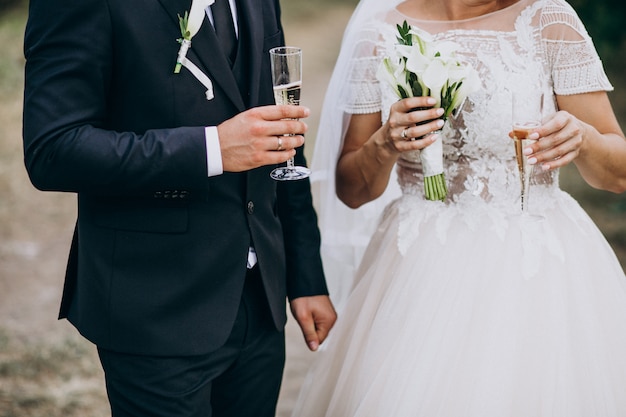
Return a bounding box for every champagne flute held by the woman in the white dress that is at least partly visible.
[512,89,543,213]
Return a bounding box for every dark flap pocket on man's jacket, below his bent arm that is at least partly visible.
[79,199,189,233]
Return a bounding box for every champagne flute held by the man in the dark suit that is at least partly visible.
[270,46,311,181]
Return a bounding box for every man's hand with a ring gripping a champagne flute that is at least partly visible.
[217,105,310,172]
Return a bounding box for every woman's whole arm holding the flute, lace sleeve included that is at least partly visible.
[531,2,626,193]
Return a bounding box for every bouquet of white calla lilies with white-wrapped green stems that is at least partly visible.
[379,20,480,201]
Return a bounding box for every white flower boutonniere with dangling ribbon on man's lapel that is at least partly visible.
[174,0,215,100]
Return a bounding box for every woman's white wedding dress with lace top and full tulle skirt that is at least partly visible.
[293,0,626,417]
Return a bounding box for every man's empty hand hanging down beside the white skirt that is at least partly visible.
[290,295,337,351]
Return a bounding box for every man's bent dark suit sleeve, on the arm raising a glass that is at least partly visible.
[23,0,206,194]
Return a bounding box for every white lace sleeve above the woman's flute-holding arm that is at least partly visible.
[541,0,613,95]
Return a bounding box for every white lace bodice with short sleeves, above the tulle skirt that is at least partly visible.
[347,0,612,211]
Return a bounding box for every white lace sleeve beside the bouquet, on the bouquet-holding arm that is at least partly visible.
[342,29,381,114]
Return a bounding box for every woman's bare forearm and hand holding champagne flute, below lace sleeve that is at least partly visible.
[531,92,626,193]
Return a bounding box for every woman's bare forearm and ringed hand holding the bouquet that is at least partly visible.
[336,97,443,208]
